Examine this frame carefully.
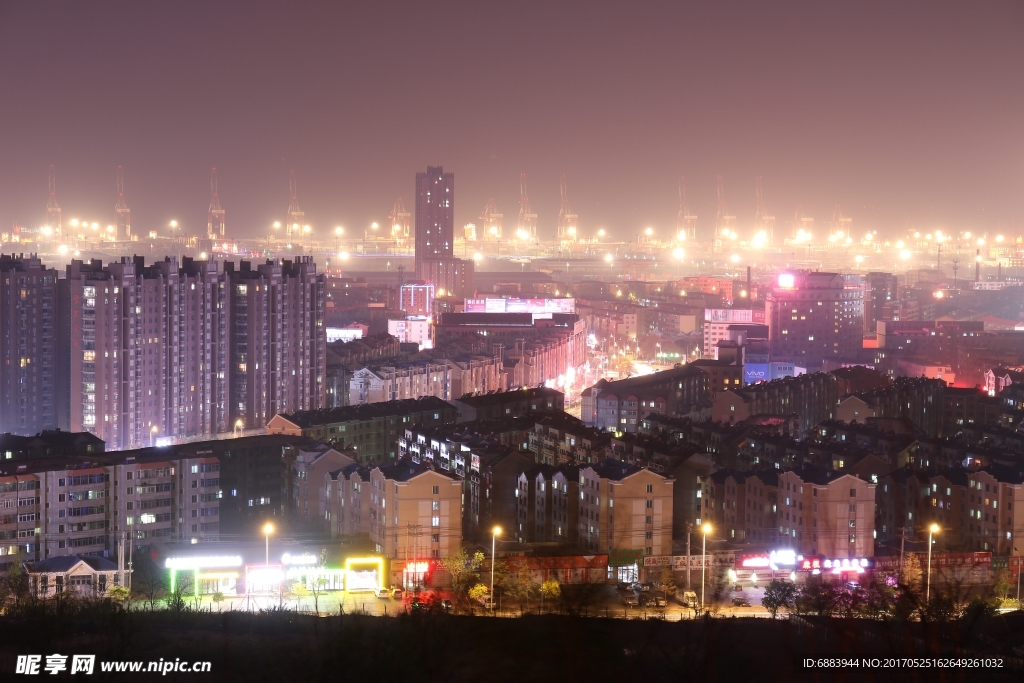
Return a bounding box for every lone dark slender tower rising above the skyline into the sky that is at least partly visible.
[416,166,455,272]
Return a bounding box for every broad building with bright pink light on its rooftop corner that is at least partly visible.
[765,270,864,371]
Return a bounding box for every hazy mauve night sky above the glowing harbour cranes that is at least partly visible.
[0,0,1024,238]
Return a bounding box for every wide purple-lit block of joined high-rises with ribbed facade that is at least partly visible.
[58,257,327,449]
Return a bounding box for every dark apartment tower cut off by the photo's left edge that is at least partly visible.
[0,254,61,436]
